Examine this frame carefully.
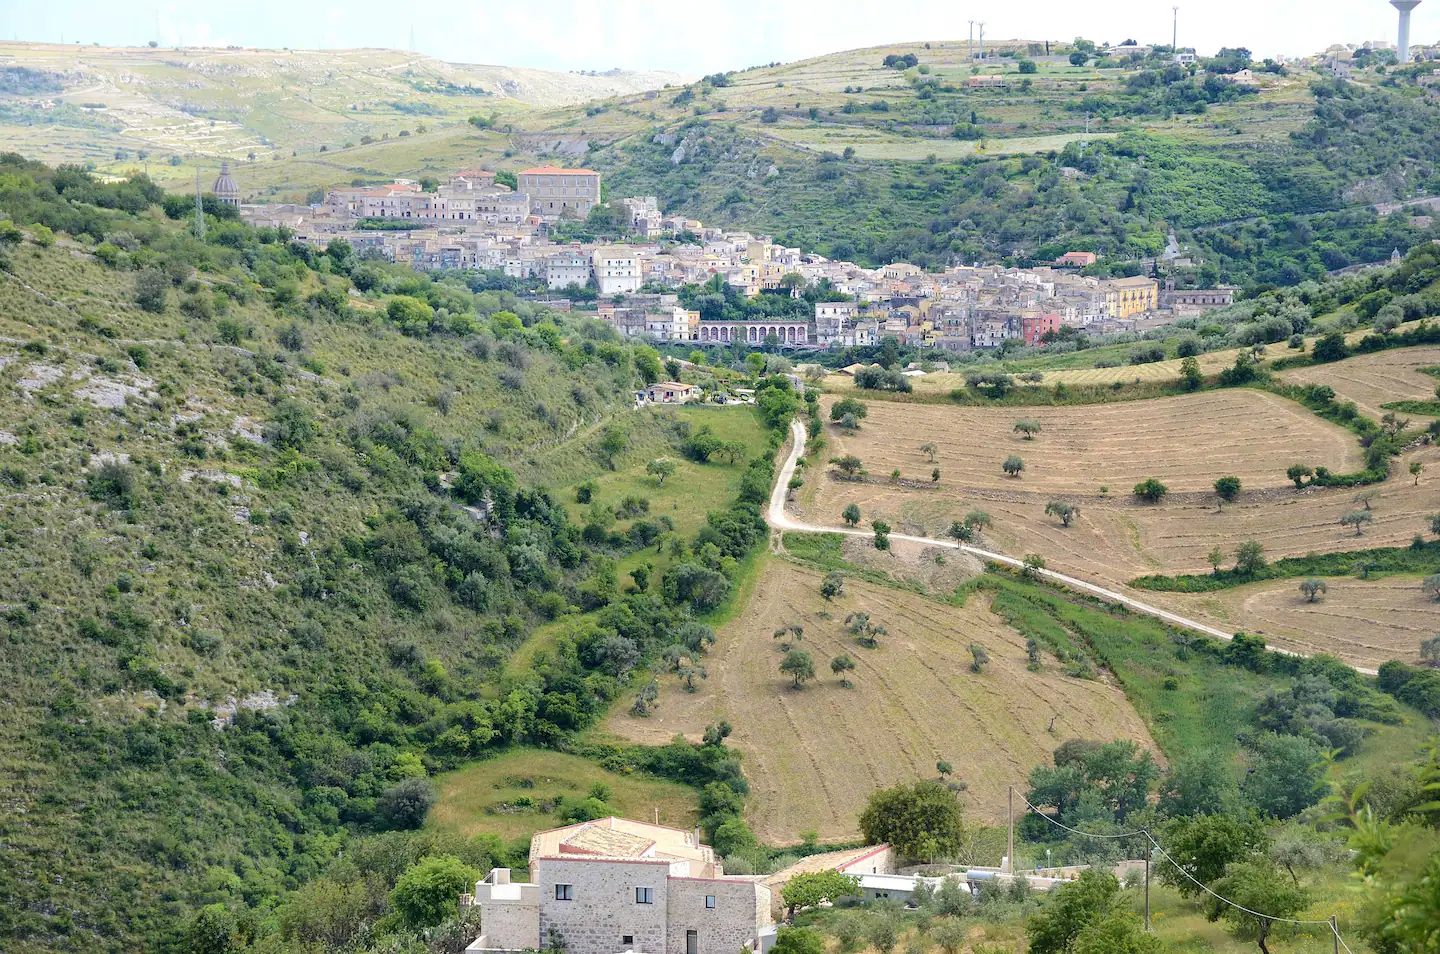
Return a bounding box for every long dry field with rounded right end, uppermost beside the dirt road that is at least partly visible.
[824,389,1362,492]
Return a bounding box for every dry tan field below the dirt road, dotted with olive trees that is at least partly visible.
[605,558,1152,843]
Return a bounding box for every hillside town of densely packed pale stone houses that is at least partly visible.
[240,166,1234,352]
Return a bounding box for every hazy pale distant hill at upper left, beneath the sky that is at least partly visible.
[0,43,687,169]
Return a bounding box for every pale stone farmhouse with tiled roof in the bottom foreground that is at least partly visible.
[461,817,772,954]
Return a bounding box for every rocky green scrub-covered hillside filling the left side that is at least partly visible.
[0,156,798,951]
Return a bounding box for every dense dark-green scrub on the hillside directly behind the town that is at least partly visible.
[588,78,1440,285]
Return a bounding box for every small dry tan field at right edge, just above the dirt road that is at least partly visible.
[1145,576,1440,669]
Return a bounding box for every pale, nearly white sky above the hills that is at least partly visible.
[0,0,1440,75]
